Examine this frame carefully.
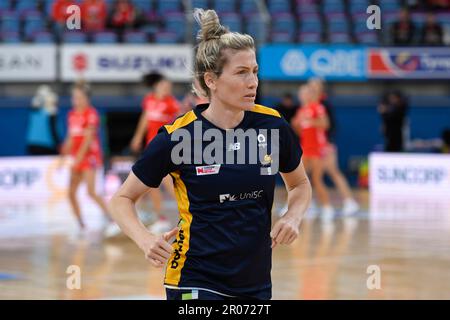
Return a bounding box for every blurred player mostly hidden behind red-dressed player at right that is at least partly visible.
[308,78,359,215]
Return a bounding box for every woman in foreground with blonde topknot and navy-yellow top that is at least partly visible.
[111,9,311,299]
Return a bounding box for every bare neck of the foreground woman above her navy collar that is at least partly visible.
[202,101,245,130]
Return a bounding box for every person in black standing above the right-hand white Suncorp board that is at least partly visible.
[378,91,408,152]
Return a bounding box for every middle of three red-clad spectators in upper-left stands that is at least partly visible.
[81,0,108,32]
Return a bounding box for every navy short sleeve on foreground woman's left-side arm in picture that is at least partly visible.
[132,128,173,188]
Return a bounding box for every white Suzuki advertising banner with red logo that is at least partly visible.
[61,45,193,82]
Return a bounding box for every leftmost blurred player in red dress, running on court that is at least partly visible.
[61,82,110,229]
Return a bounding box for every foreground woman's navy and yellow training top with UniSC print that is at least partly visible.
[132,104,302,299]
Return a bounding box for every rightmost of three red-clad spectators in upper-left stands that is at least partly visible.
[108,0,136,38]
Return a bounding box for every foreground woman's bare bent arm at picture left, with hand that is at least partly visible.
[110,172,178,268]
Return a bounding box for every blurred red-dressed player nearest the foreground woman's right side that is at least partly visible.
[292,85,334,220]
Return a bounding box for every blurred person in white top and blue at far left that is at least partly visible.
[27,85,60,155]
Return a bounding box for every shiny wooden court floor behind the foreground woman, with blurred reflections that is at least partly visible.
[0,188,450,299]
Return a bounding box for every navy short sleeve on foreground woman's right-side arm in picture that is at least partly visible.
[280,119,303,173]
